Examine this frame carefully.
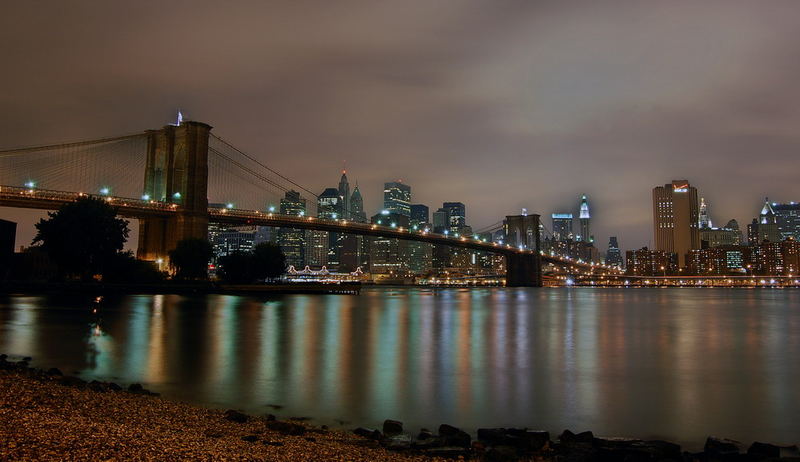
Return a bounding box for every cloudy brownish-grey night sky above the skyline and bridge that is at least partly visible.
[0,0,800,250]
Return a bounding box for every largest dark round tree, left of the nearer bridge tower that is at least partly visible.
[33,197,130,279]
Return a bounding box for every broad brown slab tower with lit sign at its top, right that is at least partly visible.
[653,180,700,267]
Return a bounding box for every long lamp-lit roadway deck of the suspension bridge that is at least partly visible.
[0,186,615,273]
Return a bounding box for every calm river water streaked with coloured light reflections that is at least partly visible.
[0,288,800,447]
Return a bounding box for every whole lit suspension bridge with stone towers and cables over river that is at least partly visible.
[0,121,614,286]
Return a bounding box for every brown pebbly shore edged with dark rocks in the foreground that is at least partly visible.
[0,355,800,462]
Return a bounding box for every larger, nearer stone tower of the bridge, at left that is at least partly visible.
[137,121,211,261]
